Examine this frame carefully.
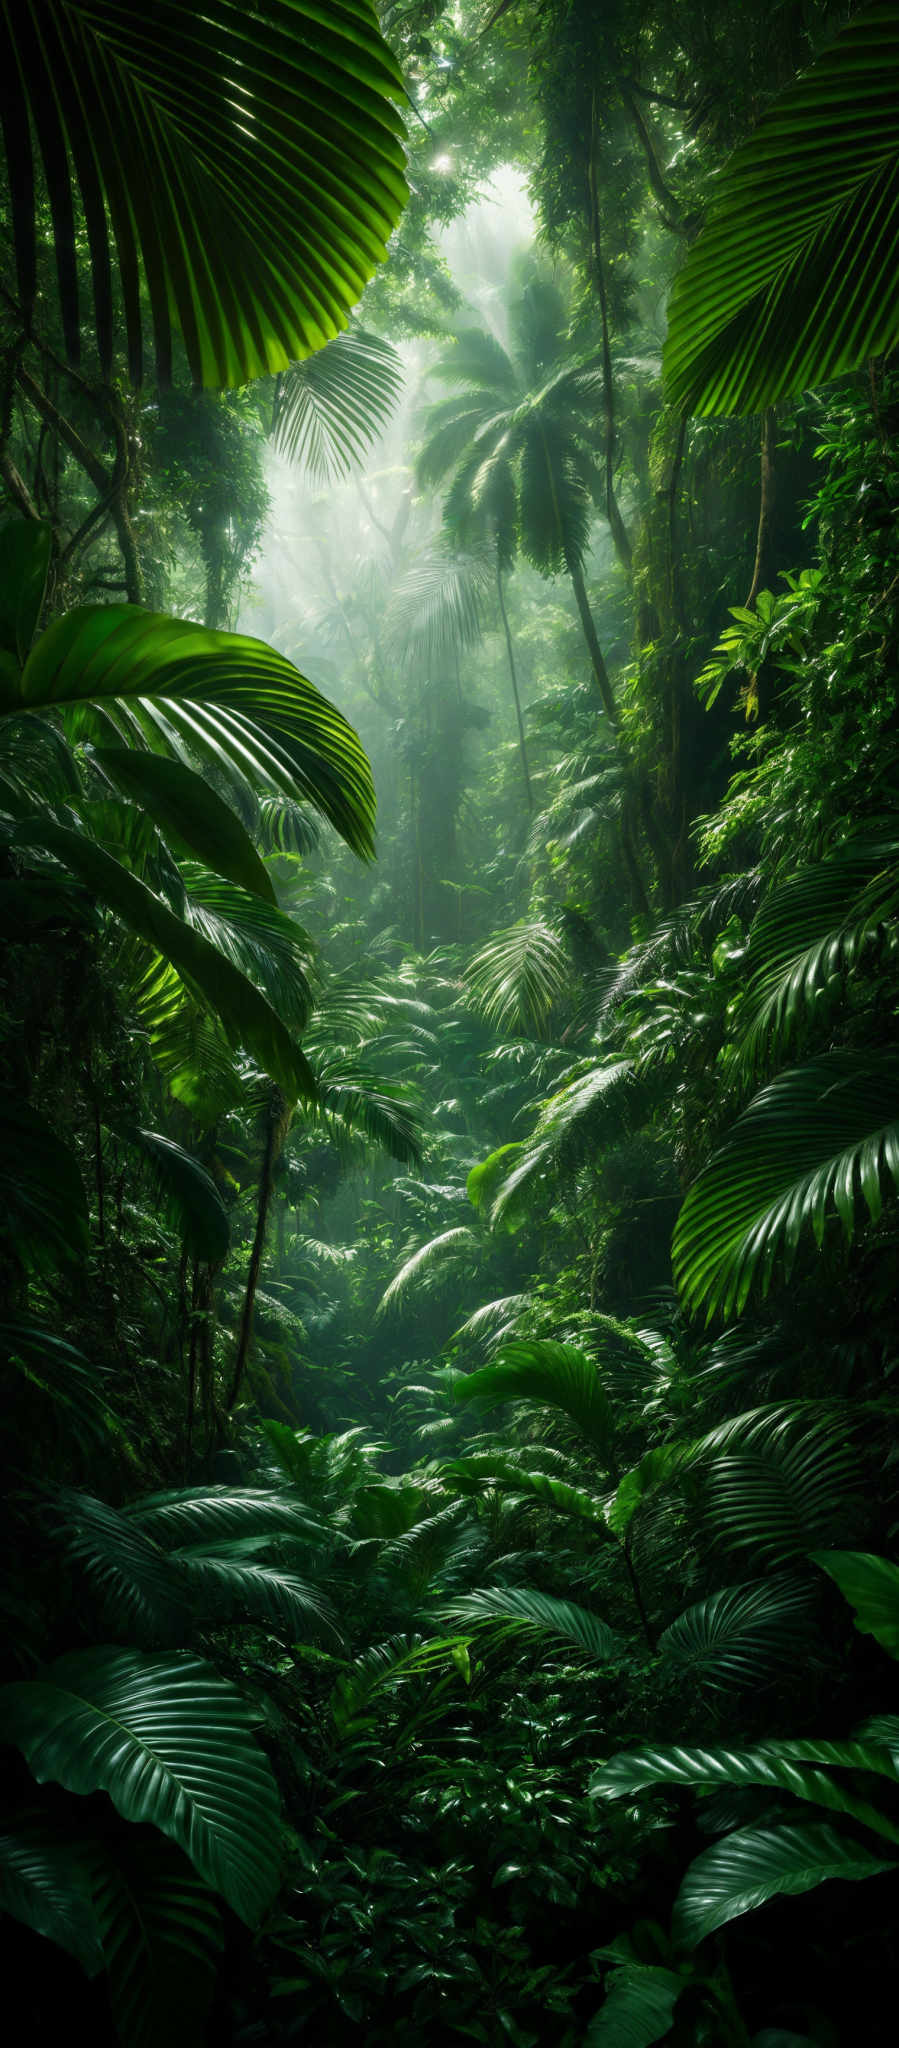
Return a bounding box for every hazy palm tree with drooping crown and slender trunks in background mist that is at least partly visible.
[418,279,618,803]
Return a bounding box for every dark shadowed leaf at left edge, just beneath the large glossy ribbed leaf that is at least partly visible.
[0,1810,104,1976]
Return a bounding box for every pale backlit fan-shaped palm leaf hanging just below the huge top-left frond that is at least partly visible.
[272,326,403,483]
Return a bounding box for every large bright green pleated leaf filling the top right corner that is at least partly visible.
[663,6,899,414]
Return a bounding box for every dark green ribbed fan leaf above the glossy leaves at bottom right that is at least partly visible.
[657,1579,809,1692]
